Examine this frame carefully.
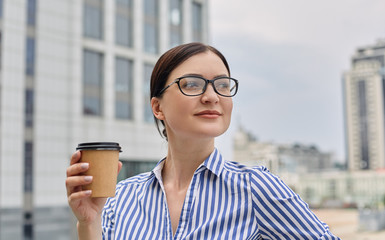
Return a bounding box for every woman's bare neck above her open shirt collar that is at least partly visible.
[162,139,214,189]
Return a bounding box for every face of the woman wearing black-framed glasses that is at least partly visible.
[153,51,233,141]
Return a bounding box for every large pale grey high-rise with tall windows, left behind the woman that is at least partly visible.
[0,0,208,240]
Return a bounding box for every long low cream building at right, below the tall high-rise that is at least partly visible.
[293,170,385,209]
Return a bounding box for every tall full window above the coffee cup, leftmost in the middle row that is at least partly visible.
[83,50,103,116]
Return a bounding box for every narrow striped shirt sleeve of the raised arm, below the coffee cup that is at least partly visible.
[102,198,116,240]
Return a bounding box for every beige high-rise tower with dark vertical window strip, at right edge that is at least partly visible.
[343,40,385,170]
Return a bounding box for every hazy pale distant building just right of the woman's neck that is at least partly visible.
[234,128,333,175]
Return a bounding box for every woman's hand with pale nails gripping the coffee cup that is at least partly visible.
[66,151,122,225]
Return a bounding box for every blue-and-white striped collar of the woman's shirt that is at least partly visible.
[148,148,225,182]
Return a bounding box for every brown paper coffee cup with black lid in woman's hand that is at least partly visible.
[76,142,121,197]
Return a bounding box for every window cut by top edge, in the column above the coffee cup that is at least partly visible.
[83,0,103,39]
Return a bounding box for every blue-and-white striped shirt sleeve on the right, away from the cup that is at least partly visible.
[250,167,340,240]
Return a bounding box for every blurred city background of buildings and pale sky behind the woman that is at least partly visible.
[0,0,385,240]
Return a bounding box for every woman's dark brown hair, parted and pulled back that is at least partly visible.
[150,42,230,140]
